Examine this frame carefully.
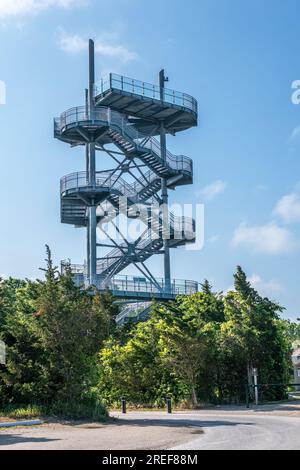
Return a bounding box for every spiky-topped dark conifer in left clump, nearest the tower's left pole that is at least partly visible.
[36,247,116,401]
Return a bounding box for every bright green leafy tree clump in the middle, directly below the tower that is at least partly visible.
[99,290,224,406]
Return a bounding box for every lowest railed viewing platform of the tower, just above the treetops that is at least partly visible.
[62,263,199,300]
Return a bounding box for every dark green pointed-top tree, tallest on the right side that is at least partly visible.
[220,267,290,396]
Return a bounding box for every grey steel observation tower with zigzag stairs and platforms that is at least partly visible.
[54,40,198,310]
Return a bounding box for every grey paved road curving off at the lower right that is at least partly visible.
[112,404,300,450]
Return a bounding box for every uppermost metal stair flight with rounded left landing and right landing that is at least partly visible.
[54,106,193,186]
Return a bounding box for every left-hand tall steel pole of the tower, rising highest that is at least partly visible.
[88,39,97,285]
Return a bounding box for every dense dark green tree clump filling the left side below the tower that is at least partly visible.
[0,247,118,417]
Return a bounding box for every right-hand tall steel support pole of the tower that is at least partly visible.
[159,70,171,292]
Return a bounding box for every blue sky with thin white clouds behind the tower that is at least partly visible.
[0,0,300,318]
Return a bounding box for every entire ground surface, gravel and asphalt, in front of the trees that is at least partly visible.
[0,403,300,450]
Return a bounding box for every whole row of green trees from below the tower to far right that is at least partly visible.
[98,267,291,406]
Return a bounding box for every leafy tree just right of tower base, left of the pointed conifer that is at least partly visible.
[156,294,224,406]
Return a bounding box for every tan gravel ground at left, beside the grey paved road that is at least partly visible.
[0,414,202,450]
